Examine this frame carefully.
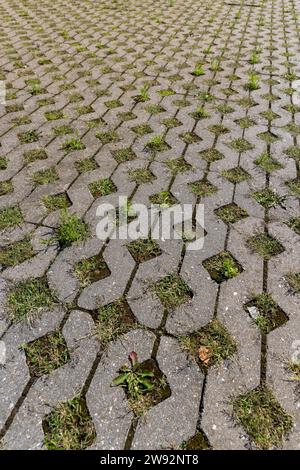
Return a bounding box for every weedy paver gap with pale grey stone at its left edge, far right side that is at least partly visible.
[245,292,288,334]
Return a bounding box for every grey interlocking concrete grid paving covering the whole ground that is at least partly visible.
[0,0,300,449]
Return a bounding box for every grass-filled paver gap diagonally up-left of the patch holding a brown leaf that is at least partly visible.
[151,274,193,310]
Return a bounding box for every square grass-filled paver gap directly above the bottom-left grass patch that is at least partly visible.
[22,331,70,377]
